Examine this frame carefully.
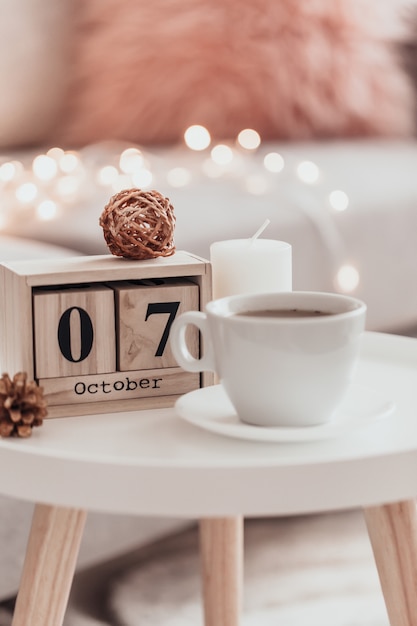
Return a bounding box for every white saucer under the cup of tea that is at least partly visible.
[175,385,395,442]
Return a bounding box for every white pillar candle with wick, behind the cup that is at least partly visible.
[210,238,292,299]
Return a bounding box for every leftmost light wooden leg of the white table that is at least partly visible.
[12,504,86,626]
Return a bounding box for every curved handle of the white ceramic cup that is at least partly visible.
[170,311,214,372]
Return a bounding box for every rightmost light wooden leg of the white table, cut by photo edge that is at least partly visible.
[364,500,417,626]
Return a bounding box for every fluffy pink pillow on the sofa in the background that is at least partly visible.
[51,0,414,145]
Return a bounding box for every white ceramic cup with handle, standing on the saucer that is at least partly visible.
[170,291,366,427]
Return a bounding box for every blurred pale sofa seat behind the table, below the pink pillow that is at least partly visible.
[4,137,417,331]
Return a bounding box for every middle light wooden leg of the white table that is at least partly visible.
[200,517,243,626]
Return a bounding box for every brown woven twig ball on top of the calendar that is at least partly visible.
[100,189,175,259]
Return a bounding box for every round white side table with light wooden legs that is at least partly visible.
[4,333,417,626]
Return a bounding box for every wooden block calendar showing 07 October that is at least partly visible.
[0,252,213,417]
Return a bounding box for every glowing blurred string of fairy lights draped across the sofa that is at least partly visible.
[0,125,360,292]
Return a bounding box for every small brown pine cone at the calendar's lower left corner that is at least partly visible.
[0,372,47,437]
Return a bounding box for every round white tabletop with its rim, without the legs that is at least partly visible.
[0,333,417,518]
